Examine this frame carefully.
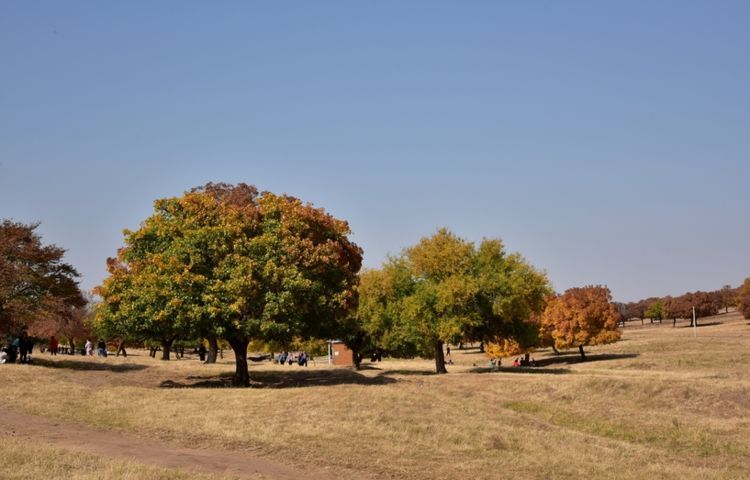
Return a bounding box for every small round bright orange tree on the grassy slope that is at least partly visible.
[541,286,620,360]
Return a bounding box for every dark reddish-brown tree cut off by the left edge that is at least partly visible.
[0,220,86,335]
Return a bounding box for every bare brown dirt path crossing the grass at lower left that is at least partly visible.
[0,409,337,480]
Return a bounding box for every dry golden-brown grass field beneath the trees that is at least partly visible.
[0,313,750,480]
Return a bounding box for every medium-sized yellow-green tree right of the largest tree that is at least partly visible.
[358,229,549,373]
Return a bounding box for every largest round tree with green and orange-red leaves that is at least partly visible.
[97,184,362,386]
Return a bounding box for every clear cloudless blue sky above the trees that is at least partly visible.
[0,0,750,301]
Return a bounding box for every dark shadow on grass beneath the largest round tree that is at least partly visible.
[159,369,396,388]
